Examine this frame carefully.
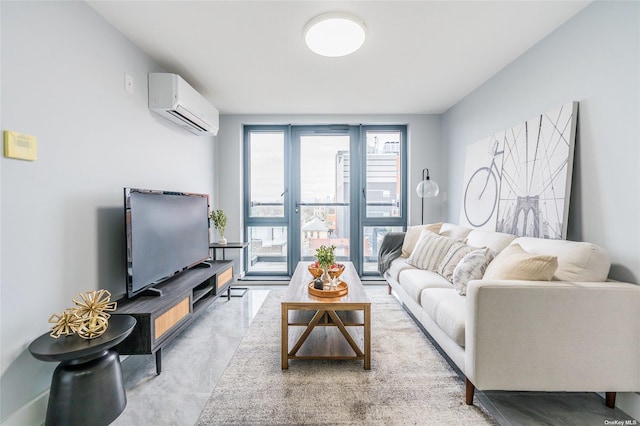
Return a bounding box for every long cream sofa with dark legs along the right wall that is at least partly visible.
[381,223,640,408]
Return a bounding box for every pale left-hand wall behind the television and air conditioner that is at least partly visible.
[0,1,215,422]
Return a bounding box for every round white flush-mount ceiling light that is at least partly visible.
[304,12,367,58]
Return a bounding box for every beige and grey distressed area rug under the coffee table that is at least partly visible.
[196,288,497,426]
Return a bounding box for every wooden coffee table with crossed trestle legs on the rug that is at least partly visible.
[282,262,371,370]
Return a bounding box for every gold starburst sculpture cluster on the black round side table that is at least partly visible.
[49,290,117,339]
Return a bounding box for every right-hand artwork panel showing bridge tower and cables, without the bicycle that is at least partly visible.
[496,102,578,239]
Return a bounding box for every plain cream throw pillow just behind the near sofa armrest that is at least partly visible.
[483,244,558,281]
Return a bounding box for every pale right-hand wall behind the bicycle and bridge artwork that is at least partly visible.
[442,2,640,418]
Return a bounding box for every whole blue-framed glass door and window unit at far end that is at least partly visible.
[244,125,407,276]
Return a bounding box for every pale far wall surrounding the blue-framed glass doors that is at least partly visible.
[215,111,446,271]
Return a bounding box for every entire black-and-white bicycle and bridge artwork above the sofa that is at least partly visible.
[460,102,578,239]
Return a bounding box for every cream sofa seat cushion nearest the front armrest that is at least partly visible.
[420,288,466,347]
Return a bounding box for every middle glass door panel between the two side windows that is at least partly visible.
[292,127,357,268]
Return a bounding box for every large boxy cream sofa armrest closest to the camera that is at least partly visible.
[465,281,640,392]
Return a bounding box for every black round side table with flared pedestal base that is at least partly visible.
[29,315,136,426]
